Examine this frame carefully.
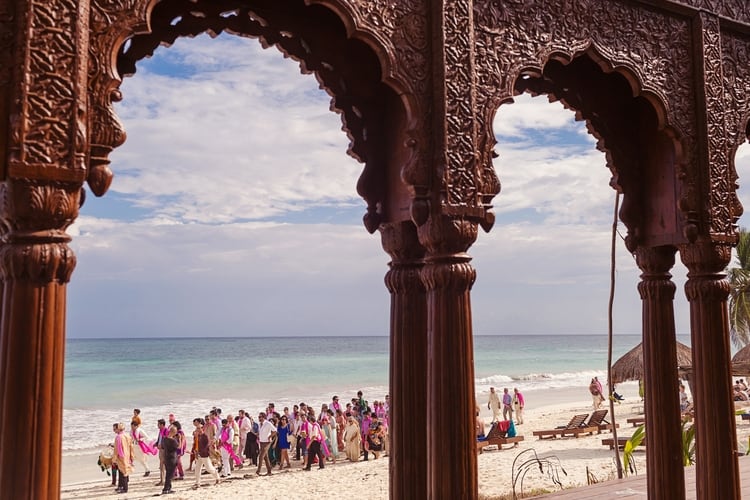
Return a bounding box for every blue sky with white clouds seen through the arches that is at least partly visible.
[67,35,750,338]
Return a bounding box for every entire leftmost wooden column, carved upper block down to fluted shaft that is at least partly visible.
[0,0,90,500]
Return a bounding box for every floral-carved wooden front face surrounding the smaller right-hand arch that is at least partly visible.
[474,0,699,240]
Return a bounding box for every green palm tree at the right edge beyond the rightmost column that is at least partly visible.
[727,228,750,349]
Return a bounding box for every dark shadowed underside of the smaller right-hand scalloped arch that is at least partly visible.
[486,47,686,252]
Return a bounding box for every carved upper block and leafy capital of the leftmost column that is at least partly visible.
[0,0,88,282]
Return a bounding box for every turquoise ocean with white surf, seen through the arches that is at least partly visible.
[63,335,690,455]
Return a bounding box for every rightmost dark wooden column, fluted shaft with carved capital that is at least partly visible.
[680,242,741,500]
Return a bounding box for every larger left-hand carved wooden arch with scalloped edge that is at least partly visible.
[87,0,429,232]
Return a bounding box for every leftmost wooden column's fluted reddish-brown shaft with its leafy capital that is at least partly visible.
[0,181,80,500]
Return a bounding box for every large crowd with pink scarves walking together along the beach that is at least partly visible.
[105,391,389,494]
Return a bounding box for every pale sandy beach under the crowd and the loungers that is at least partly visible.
[62,383,680,500]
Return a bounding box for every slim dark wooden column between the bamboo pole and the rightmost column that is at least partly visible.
[636,247,685,500]
